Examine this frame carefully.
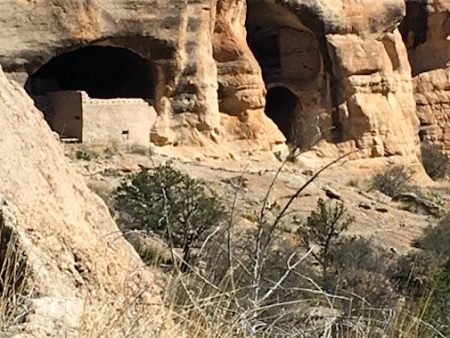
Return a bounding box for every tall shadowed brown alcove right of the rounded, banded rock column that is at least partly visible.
[245,0,344,149]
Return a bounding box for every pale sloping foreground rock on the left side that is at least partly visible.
[0,68,163,337]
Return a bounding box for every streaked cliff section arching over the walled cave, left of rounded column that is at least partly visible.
[0,0,218,143]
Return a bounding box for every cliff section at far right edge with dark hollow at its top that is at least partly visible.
[401,0,450,150]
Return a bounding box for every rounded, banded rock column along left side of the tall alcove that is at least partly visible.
[213,0,284,149]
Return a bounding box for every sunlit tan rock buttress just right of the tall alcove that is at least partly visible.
[328,30,418,157]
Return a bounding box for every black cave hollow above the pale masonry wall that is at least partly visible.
[25,46,157,99]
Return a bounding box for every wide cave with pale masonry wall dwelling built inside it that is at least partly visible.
[25,46,158,144]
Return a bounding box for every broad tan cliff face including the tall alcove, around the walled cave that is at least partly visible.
[0,0,418,156]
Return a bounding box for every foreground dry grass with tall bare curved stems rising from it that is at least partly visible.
[149,153,445,338]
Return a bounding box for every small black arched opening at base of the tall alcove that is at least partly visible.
[265,87,298,143]
